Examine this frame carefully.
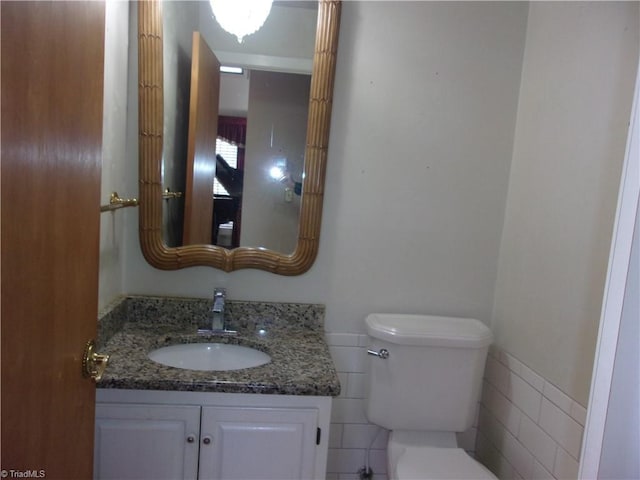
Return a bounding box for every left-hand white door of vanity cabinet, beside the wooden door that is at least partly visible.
[93,404,200,480]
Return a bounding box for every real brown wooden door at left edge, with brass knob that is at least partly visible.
[0,1,105,480]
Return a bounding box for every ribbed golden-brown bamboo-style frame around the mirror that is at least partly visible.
[138,0,341,275]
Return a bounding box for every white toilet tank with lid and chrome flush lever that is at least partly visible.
[365,314,493,432]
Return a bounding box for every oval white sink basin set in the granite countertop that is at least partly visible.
[149,343,271,371]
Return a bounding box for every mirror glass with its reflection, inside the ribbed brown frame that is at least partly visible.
[163,1,318,249]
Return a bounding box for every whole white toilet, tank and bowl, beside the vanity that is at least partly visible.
[365,314,497,480]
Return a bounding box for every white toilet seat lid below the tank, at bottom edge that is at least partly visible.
[394,447,497,480]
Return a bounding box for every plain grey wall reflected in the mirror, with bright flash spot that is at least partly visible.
[240,70,311,254]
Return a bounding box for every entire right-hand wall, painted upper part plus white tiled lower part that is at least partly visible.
[476,2,638,479]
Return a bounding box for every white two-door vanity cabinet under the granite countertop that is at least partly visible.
[94,389,331,480]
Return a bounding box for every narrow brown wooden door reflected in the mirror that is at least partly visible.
[182,32,220,245]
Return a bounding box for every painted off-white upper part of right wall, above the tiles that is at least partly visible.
[492,2,639,406]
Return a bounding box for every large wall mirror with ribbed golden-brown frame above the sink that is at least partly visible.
[138,0,340,275]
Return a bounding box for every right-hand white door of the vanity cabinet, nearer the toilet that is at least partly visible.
[200,407,318,480]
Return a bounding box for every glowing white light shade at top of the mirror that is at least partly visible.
[209,0,272,43]
